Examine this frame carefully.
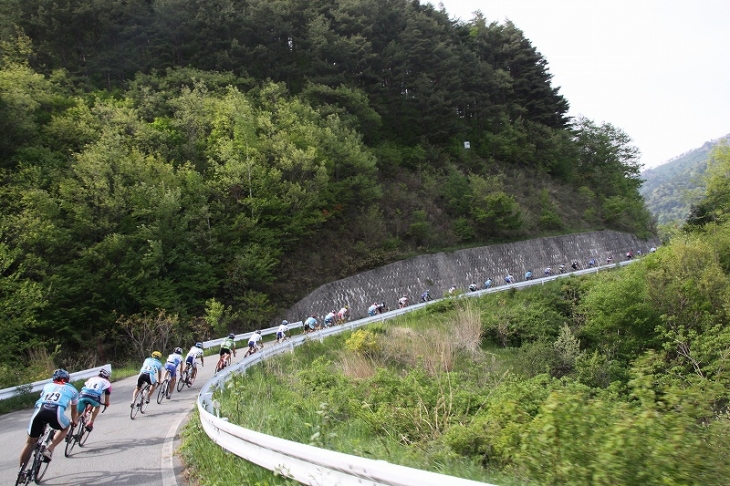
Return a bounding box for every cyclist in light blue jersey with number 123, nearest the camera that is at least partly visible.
[20,369,79,467]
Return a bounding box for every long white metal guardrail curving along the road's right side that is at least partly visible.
[198,260,633,486]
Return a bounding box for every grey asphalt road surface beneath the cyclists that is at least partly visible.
[0,353,230,486]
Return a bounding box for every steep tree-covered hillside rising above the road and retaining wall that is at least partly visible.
[0,0,655,385]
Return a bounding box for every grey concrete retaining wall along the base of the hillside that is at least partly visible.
[283,231,658,321]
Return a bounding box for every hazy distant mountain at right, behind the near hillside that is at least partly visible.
[639,134,730,224]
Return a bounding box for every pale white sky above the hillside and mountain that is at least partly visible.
[432,0,730,168]
